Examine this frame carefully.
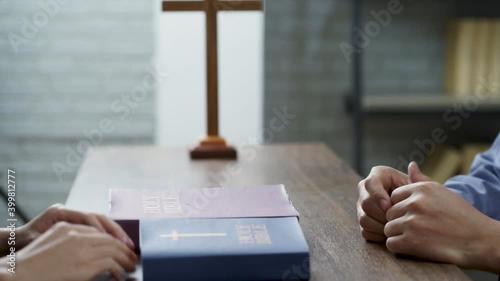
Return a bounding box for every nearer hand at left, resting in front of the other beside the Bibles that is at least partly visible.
[11,222,137,281]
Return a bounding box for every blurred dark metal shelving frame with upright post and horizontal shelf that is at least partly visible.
[346,0,500,175]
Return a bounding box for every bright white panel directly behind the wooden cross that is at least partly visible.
[155,11,264,146]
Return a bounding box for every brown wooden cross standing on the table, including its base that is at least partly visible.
[162,0,262,159]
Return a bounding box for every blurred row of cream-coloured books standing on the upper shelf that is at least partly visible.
[445,18,500,97]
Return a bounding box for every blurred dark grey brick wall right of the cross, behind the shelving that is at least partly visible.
[264,0,500,175]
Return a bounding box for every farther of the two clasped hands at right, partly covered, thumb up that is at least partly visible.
[357,162,429,242]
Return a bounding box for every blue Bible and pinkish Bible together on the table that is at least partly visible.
[110,185,310,281]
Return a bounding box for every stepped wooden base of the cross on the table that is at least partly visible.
[190,136,237,159]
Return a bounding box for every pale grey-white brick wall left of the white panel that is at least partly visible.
[0,0,156,217]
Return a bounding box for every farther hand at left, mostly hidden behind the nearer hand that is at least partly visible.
[16,204,134,249]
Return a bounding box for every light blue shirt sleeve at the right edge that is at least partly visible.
[444,134,500,220]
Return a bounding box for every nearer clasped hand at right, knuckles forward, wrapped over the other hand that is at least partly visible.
[384,177,500,273]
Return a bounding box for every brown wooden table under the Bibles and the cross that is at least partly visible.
[66,144,469,281]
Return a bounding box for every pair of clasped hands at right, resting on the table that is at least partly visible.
[357,162,500,272]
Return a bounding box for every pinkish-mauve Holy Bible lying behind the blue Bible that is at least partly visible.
[109,185,299,251]
